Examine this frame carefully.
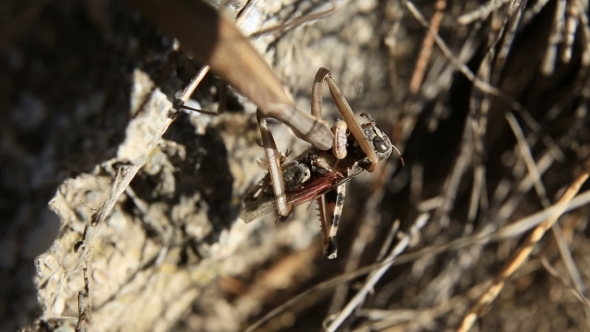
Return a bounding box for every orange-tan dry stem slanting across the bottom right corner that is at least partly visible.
[457,163,590,332]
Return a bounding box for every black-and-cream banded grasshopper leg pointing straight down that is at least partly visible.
[318,183,346,259]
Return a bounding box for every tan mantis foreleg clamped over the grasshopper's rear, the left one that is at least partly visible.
[256,111,292,217]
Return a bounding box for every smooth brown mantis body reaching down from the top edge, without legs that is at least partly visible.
[125,0,333,150]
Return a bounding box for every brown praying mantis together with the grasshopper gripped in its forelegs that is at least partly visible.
[137,0,399,258]
